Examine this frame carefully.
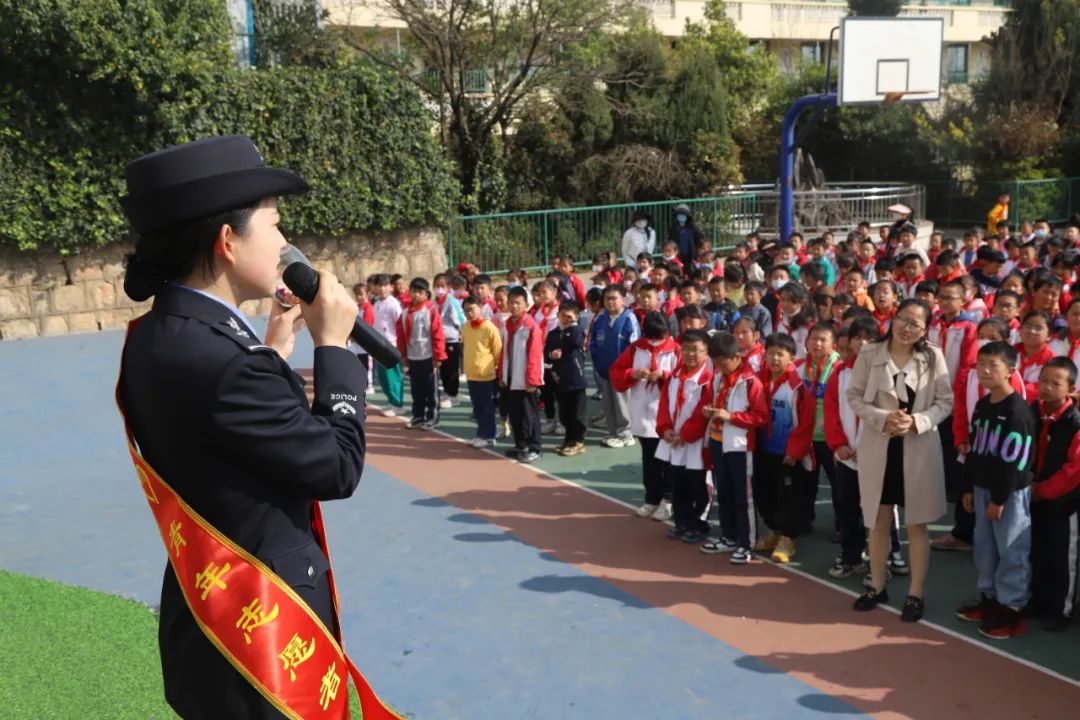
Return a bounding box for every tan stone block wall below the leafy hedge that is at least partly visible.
[0,228,446,340]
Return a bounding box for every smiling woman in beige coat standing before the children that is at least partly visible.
[847,299,953,623]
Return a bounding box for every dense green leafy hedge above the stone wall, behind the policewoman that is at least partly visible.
[0,0,458,254]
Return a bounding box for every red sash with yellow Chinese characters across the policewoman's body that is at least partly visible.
[117,317,402,720]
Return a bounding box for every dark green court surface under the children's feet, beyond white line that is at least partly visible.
[380,378,1080,680]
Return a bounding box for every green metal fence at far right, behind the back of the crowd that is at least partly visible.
[919,177,1080,228]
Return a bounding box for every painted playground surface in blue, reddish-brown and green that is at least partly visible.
[0,328,1080,720]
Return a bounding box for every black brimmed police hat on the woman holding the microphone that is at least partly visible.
[120,135,309,233]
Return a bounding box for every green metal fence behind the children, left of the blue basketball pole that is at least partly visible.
[447,192,758,273]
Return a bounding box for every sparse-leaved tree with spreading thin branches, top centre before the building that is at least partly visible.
[332,0,633,209]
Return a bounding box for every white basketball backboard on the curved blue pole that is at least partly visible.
[838,17,945,105]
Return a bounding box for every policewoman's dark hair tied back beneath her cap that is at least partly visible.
[124,201,262,302]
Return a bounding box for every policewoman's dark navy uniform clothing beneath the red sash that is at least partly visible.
[121,285,366,720]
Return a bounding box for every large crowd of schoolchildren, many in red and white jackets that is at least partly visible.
[356,218,1080,639]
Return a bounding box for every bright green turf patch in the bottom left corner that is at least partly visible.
[0,570,360,720]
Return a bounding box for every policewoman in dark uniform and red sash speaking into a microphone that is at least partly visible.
[117,136,396,720]
